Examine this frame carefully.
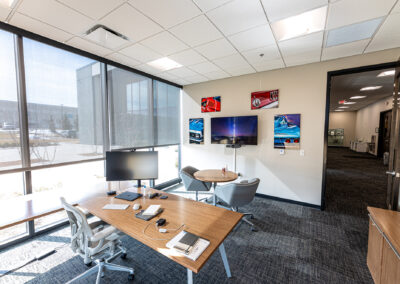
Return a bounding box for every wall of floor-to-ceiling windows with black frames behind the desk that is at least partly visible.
[0,26,181,248]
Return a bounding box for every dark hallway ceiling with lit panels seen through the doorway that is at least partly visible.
[329,69,394,111]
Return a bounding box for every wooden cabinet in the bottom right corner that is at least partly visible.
[367,207,400,284]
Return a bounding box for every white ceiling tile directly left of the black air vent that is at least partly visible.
[18,0,94,35]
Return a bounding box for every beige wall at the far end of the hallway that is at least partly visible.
[329,111,356,147]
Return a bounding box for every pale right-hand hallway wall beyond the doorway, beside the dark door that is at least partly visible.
[355,98,392,153]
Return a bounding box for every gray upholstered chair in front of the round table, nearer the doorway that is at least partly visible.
[215,178,260,231]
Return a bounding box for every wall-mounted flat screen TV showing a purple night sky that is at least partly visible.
[211,115,258,145]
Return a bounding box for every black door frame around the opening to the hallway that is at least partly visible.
[321,61,397,210]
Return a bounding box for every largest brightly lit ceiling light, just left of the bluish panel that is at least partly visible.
[271,6,327,41]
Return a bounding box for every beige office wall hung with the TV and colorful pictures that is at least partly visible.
[182,49,400,205]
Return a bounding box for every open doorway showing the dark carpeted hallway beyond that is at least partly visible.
[321,62,400,213]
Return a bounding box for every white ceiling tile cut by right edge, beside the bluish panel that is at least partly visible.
[366,13,400,52]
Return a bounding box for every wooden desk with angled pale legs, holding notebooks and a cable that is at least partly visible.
[79,187,243,283]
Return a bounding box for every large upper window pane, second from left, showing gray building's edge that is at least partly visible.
[24,39,104,166]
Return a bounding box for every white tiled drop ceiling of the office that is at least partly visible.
[0,0,400,85]
